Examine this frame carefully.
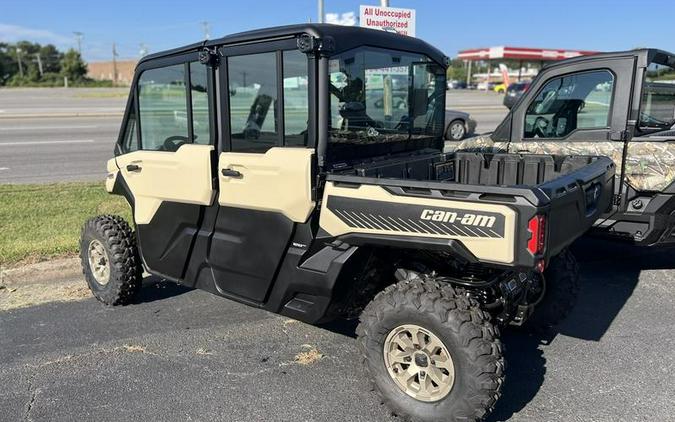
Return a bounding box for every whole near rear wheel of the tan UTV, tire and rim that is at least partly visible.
[357,278,504,421]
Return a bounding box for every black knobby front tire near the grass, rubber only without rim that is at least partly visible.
[80,215,143,306]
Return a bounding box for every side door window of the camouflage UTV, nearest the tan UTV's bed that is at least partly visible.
[524,70,614,138]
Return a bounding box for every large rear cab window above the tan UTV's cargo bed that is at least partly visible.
[328,47,445,162]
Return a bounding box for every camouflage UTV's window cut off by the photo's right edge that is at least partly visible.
[640,54,675,133]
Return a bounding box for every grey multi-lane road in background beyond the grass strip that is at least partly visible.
[0,88,506,183]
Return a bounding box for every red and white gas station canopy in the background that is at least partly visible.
[457,47,597,62]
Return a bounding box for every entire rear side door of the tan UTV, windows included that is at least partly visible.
[208,40,315,303]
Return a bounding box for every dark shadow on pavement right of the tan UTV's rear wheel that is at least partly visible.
[488,238,675,421]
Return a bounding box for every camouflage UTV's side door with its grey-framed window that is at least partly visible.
[504,56,635,171]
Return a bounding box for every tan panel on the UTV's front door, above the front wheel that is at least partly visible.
[117,144,214,224]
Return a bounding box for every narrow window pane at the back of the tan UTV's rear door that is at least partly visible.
[283,50,309,146]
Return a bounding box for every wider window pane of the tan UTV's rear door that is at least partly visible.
[227,52,279,152]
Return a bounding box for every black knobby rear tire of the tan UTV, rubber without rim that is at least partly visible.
[356,277,505,421]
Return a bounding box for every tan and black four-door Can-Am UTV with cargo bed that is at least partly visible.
[81,25,614,421]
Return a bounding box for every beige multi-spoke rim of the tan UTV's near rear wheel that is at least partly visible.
[384,324,455,402]
